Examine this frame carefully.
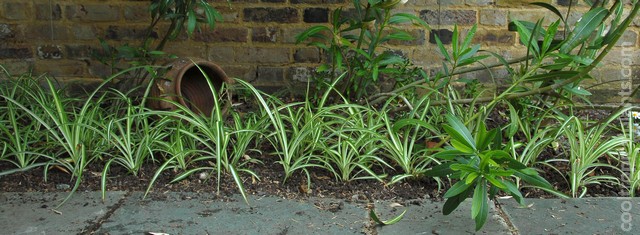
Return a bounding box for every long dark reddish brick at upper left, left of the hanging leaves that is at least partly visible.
[65,4,120,22]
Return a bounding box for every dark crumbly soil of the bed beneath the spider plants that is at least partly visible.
[0,149,624,202]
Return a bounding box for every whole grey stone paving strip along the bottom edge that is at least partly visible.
[0,192,640,235]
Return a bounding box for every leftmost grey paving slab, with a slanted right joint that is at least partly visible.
[0,192,125,234]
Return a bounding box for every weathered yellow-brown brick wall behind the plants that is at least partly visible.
[0,0,640,99]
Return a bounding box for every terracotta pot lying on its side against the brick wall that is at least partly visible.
[149,58,233,116]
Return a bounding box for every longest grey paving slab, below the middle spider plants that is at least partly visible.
[97,192,369,235]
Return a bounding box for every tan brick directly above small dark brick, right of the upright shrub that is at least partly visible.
[420,10,476,25]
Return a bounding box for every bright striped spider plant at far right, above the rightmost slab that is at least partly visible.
[562,109,629,198]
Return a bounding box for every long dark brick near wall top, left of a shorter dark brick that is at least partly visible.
[243,7,300,23]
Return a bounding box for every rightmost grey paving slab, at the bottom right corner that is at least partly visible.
[499,197,640,234]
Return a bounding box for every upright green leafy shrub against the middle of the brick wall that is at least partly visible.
[296,0,428,98]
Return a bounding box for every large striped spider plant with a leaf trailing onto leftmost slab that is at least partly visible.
[0,65,148,207]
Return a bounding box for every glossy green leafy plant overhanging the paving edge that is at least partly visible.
[426,115,551,230]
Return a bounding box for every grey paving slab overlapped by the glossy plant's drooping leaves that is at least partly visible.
[375,199,512,235]
